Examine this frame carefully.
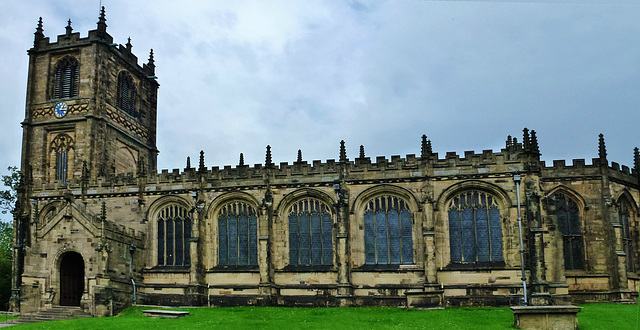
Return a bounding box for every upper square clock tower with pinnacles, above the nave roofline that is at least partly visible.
[21,7,159,186]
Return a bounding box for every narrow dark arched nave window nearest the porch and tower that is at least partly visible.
[158,205,191,266]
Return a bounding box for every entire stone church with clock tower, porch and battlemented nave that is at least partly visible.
[12,8,640,316]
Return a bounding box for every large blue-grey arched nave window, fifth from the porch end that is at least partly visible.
[448,190,504,263]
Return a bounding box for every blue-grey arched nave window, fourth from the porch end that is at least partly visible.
[364,195,413,265]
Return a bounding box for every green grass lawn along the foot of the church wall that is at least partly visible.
[12,304,638,330]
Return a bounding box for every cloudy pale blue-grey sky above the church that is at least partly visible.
[0,0,640,180]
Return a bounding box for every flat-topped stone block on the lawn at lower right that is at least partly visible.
[511,305,582,330]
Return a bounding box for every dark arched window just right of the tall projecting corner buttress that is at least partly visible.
[549,192,584,269]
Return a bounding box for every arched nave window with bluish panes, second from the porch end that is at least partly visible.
[218,201,258,266]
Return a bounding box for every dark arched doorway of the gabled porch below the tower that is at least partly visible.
[60,252,84,306]
